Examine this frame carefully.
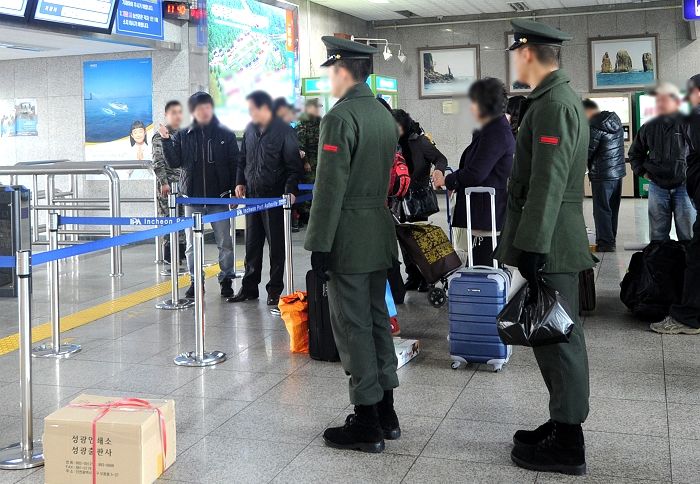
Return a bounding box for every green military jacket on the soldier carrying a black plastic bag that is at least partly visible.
[496,70,594,273]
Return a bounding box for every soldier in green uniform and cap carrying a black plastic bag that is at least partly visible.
[496,19,594,474]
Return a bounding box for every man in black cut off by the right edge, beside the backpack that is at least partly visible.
[651,74,700,334]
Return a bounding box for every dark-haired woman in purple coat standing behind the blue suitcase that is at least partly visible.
[444,77,515,265]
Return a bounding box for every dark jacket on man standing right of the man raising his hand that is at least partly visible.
[238,118,304,197]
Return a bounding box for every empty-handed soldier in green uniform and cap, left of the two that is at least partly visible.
[304,37,401,452]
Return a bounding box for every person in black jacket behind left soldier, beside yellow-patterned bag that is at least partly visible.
[392,109,447,292]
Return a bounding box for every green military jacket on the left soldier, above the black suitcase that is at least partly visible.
[304,83,399,274]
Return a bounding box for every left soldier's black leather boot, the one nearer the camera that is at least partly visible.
[323,405,384,453]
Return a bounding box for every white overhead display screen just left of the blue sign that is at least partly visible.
[34,0,118,32]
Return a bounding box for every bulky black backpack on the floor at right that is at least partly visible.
[620,240,686,321]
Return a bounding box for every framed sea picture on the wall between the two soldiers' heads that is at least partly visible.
[418,45,481,99]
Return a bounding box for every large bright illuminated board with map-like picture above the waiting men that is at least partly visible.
[207,0,300,131]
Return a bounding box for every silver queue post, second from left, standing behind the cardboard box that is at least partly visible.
[32,212,82,358]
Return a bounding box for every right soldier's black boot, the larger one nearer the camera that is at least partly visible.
[510,421,586,476]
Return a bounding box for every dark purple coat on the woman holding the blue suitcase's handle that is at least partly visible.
[445,116,515,230]
